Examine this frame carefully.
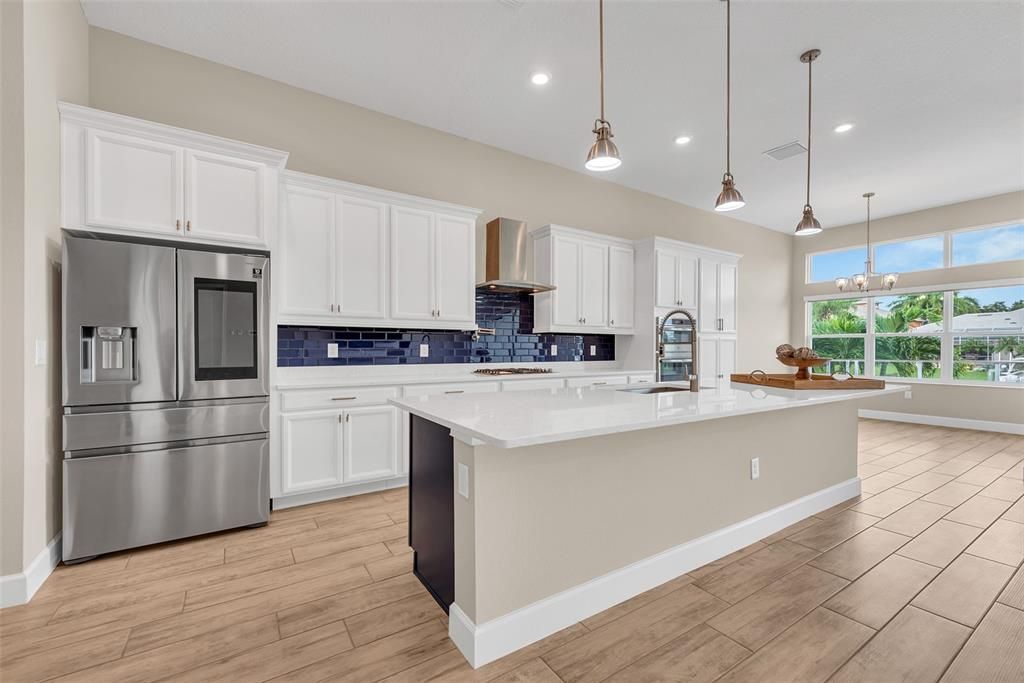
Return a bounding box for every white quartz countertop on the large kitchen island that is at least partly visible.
[390,383,906,449]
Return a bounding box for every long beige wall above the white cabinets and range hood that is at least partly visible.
[90,28,792,376]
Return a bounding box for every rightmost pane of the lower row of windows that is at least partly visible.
[952,286,1024,383]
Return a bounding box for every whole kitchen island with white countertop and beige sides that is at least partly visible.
[391,384,903,667]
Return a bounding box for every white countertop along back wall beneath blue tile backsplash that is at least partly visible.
[274,364,654,391]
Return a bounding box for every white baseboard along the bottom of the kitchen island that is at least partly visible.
[449,477,860,669]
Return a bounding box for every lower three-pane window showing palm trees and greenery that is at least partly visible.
[807,285,1024,386]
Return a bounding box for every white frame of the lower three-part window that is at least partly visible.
[804,274,1024,390]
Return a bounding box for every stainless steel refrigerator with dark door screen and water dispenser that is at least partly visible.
[62,230,270,562]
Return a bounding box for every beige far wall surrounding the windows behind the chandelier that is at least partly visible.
[791,191,1024,424]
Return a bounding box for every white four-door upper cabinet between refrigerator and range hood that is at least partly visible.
[276,171,478,330]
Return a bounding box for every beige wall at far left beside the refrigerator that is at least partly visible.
[2,0,89,574]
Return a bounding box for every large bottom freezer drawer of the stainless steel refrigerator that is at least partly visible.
[63,438,270,561]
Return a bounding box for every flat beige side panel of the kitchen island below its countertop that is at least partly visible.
[455,400,863,625]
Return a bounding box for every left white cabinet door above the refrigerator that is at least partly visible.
[85,130,184,236]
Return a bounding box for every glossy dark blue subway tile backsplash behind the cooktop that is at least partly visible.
[278,292,615,367]
